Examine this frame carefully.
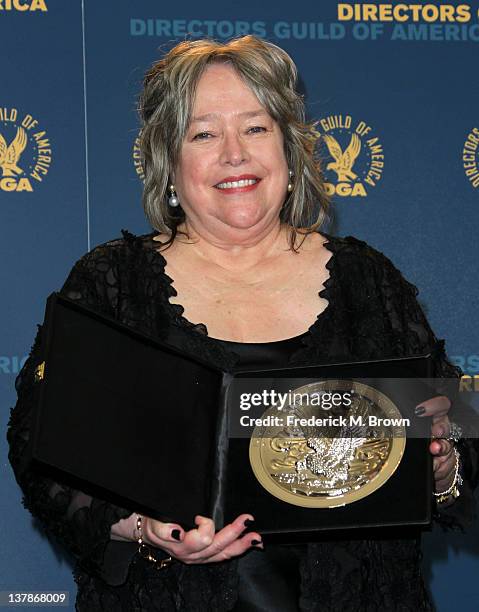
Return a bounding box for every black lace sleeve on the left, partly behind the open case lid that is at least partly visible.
[7,249,135,581]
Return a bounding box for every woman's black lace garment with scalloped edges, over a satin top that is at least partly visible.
[8,232,478,612]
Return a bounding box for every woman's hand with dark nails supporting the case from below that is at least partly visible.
[141,514,263,565]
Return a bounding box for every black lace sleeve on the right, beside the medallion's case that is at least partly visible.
[380,247,479,531]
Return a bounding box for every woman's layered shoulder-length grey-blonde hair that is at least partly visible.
[138,36,328,249]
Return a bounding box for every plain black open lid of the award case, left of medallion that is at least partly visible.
[32,293,223,520]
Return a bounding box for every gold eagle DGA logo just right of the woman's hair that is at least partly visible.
[316,115,384,197]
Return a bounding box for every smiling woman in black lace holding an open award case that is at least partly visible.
[9,36,476,611]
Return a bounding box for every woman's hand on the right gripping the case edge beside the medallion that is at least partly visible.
[416,395,456,493]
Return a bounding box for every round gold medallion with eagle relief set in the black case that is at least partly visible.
[249,380,406,508]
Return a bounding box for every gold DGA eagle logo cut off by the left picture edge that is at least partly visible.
[0,107,52,191]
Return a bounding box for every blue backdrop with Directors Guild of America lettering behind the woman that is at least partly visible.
[0,0,479,612]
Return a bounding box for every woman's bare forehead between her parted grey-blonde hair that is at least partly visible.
[192,64,264,121]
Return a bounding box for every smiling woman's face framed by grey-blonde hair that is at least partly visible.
[174,64,288,237]
